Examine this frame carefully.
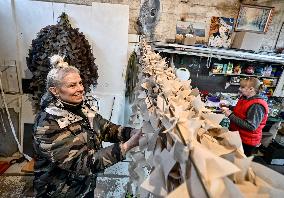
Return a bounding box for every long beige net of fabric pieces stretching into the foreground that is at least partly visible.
[128,41,284,197]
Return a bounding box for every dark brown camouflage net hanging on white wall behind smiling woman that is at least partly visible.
[26,13,98,109]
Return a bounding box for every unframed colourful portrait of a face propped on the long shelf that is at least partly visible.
[208,17,234,48]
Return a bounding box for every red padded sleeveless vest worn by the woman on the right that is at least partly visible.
[230,98,268,146]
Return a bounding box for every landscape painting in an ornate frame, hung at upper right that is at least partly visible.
[235,4,273,33]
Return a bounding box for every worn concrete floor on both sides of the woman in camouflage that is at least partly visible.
[0,162,132,198]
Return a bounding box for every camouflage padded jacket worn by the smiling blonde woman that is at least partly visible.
[33,101,131,198]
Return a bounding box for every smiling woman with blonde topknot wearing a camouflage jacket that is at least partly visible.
[33,56,141,198]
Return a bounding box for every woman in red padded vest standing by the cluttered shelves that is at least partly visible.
[222,77,268,156]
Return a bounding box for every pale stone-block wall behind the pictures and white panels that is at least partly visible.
[36,0,284,50]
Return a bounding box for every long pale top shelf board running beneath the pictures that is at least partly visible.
[153,42,284,64]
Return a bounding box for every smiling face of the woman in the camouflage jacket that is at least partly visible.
[51,72,84,104]
